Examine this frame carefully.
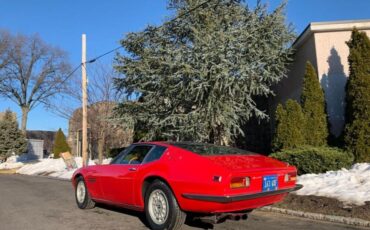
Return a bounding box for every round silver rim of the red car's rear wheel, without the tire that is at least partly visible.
[148,189,169,225]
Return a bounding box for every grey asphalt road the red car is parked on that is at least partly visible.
[0,175,368,230]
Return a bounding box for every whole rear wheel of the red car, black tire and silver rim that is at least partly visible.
[145,180,186,230]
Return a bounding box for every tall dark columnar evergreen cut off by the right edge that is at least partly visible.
[345,29,370,162]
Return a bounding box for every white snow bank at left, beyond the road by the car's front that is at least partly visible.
[0,156,111,179]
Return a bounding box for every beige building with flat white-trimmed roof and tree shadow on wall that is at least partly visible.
[270,19,370,136]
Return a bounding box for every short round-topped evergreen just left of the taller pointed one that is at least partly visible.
[272,99,306,151]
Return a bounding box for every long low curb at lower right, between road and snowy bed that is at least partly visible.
[259,206,370,227]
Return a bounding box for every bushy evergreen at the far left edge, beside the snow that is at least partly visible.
[0,110,27,158]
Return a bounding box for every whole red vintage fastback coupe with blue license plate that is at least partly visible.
[72,142,302,229]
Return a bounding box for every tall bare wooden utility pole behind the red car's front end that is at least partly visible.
[81,34,88,166]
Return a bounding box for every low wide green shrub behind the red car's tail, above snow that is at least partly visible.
[270,146,354,175]
